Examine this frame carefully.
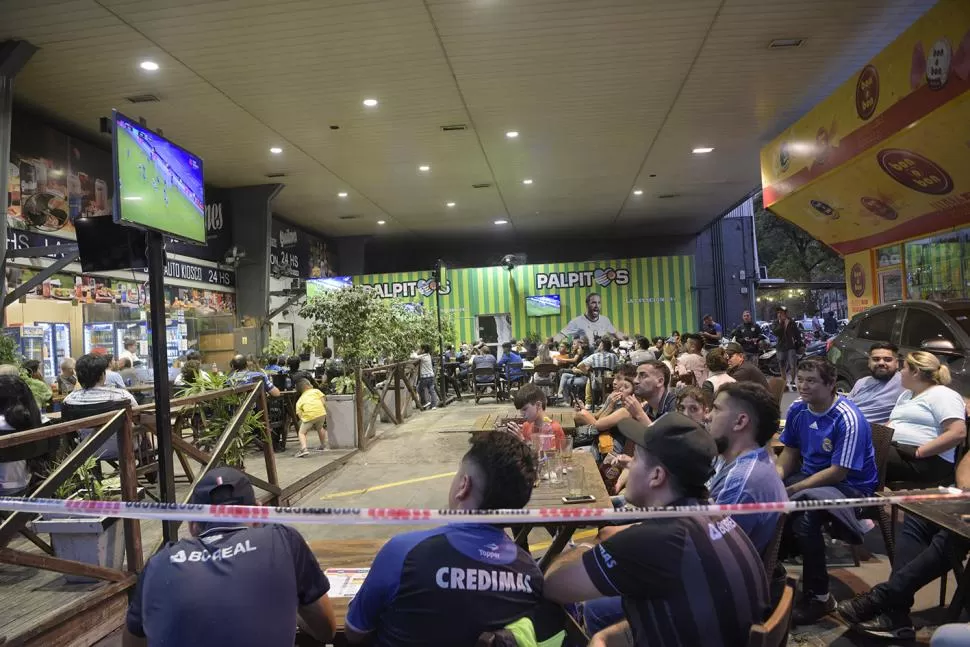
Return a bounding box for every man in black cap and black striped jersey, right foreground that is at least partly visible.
[545,413,768,647]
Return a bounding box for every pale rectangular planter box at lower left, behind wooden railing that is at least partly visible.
[31,517,125,583]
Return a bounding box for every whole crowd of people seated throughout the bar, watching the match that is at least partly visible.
[0,313,970,647]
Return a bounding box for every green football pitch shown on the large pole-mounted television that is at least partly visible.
[117,128,205,243]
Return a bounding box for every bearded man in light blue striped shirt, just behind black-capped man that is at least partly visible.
[707,382,788,556]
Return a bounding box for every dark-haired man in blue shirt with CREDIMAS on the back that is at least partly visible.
[346,432,542,647]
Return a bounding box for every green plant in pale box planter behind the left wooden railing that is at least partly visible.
[31,457,144,583]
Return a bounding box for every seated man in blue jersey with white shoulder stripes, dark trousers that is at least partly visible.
[777,357,879,624]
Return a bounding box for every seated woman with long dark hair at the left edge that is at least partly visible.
[0,375,41,496]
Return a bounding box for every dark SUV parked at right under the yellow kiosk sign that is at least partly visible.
[828,299,970,398]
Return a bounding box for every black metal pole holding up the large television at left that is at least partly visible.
[145,231,178,542]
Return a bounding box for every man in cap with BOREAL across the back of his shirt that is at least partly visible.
[123,467,336,647]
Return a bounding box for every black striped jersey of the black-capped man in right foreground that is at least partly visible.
[582,500,768,647]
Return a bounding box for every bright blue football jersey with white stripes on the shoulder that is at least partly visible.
[781,395,879,496]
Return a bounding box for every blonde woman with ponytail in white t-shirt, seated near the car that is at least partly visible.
[886,351,967,486]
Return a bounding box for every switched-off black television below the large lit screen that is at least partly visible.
[74,216,148,272]
